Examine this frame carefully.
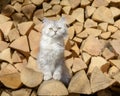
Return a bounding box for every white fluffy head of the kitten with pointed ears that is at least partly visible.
[42,17,67,38]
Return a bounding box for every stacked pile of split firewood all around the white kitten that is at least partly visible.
[0,0,120,96]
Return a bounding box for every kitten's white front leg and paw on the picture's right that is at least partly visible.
[53,65,62,80]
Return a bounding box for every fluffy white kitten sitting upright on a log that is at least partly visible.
[37,17,70,83]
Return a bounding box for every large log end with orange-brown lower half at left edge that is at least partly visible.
[0,64,22,89]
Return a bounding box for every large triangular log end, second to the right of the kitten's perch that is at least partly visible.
[90,67,115,93]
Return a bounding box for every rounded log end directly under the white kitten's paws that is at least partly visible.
[37,80,68,95]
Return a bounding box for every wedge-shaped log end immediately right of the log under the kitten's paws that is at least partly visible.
[68,70,91,94]
